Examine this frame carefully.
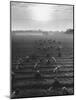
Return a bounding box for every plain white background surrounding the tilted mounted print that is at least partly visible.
[0,0,76,100]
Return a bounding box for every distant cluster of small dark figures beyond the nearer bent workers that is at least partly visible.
[35,39,62,57]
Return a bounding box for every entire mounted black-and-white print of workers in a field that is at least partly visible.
[10,1,74,99]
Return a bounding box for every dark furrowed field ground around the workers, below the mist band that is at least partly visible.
[11,35,74,98]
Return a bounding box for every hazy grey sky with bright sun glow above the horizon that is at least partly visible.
[11,2,73,31]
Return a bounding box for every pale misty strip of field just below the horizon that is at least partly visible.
[11,30,73,46]
